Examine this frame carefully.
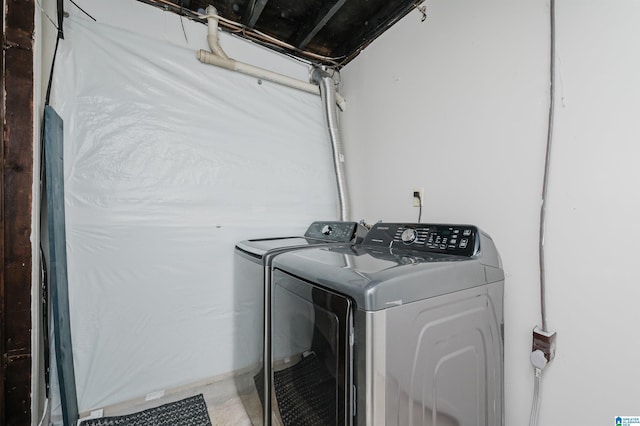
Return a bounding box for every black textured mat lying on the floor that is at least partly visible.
[80,394,211,426]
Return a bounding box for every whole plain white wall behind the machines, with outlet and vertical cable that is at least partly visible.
[342,0,640,426]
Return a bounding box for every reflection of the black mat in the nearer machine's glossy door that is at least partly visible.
[254,353,336,426]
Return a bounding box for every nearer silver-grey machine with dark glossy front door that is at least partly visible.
[265,223,504,426]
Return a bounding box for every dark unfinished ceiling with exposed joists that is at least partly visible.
[139,0,424,68]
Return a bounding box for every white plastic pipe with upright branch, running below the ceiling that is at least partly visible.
[196,6,347,111]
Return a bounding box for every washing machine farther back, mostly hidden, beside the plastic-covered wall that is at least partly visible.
[233,221,367,425]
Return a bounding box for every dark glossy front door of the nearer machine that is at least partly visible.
[271,270,353,426]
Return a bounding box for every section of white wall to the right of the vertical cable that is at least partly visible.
[544,0,640,425]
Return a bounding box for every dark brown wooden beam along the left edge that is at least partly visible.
[0,0,35,425]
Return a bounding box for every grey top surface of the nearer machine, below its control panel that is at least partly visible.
[273,225,504,311]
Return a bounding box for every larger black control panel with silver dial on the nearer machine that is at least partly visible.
[363,223,480,257]
